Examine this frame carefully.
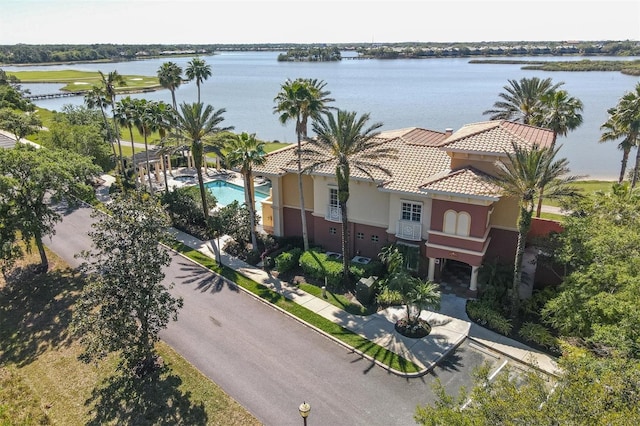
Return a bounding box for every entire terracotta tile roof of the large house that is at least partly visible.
[254,121,553,198]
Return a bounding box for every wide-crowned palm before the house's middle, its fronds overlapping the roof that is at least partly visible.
[302,110,396,285]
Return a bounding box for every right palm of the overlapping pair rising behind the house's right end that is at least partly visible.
[531,90,583,217]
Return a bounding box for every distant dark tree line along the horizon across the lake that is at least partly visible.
[0,40,640,64]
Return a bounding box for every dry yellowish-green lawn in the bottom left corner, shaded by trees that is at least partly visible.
[0,250,260,426]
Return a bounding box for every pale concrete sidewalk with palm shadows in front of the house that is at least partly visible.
[166,228,559,376]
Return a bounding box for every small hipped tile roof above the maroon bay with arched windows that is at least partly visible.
[422,167,500,199]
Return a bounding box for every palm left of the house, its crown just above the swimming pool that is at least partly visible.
[175,102,233,220]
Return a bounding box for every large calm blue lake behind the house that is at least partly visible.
[3,52,640,179]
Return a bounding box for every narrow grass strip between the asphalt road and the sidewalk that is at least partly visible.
[168,241,421,373]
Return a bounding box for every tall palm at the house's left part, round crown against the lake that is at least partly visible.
[273,78,334,251]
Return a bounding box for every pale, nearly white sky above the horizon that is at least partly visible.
[0,0,640,45]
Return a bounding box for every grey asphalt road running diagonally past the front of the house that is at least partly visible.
[45,203,500,426]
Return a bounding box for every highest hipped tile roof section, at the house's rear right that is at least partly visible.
[440,120,553,155]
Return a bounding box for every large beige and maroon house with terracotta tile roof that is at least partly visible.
[254,120,553,291]
